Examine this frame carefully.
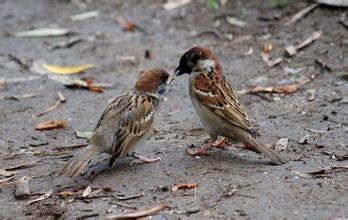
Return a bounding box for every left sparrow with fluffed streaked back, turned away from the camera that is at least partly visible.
[60,68,169,177]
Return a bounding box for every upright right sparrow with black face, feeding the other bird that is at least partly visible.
[168,46,285,165]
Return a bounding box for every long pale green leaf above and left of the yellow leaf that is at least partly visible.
[11,28,72,37]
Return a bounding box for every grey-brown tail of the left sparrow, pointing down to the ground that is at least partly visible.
[60,145,102,177]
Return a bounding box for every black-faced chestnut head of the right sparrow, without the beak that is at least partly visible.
[175,46,221,76]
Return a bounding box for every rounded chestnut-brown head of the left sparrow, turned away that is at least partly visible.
[135,68,169,94]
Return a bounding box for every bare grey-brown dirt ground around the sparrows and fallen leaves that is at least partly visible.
[0,0,348,219]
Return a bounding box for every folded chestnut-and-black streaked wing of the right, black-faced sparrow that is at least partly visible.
[192,72,255,134]
